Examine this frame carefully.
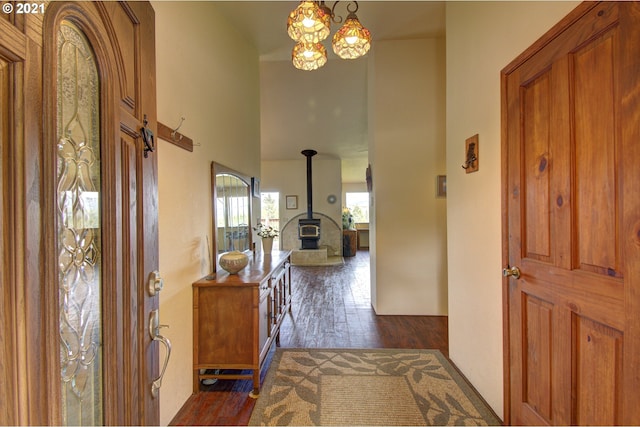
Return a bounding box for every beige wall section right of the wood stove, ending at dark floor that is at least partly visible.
[369,39,447,315]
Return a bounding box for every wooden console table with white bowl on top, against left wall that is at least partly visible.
[192,251,291,397]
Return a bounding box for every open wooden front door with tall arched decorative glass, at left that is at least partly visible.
[0,1,159,425]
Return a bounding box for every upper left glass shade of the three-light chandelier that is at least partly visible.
[287,1,331,43]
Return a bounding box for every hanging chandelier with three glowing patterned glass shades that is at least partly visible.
[287,0,371,71]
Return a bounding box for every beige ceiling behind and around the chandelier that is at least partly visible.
[216,1,445,182]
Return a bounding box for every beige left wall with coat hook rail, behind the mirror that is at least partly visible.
[152,1,260,425]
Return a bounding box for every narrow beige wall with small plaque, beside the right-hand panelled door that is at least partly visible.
[447,1,577,416]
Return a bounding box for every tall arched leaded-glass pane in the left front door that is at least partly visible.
[56,21,103,425]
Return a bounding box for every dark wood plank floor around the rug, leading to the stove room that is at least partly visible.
[171,251,449,425]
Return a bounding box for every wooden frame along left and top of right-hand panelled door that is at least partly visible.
[500,2,599,425]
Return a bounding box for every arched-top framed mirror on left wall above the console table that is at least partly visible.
[211,162,252,265]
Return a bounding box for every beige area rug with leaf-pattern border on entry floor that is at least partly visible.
[249,348,501,426]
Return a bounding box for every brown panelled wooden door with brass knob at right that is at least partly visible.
[502,2,640,425]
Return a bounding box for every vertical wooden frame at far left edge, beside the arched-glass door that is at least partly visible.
[0,9,49,425]
